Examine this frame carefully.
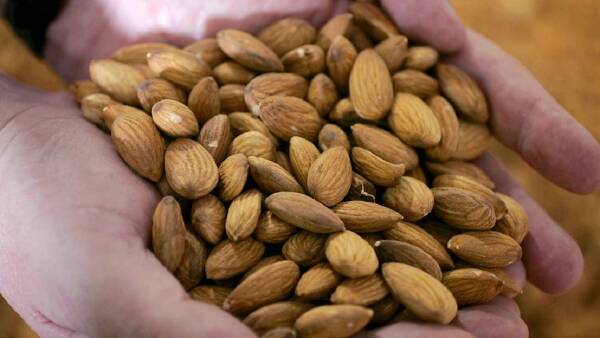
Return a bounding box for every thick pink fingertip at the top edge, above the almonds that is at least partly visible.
[381,0,466,53]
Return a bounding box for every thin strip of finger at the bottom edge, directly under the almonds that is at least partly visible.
[357,322,474,338]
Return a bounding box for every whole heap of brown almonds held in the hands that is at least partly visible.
[72,2,527,337]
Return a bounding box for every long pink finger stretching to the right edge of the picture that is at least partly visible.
[450,31,600,193]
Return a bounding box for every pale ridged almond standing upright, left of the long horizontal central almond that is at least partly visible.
[225,189,263,241]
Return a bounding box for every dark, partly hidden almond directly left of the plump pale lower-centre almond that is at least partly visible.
[281,230,327,266]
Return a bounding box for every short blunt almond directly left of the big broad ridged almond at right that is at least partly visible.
[383,176,434,222]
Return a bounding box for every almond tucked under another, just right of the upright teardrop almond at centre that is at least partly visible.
[352,147,405,187]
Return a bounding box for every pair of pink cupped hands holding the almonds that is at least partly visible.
[0,0,600,338]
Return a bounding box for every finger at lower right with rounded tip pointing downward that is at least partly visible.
[477,153,583,293]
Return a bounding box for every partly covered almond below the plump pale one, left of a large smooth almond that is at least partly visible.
[331,273,390,306]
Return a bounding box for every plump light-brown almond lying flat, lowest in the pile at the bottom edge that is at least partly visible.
[294,305,373,338]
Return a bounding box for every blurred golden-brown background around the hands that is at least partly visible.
[0,0,600,338]
